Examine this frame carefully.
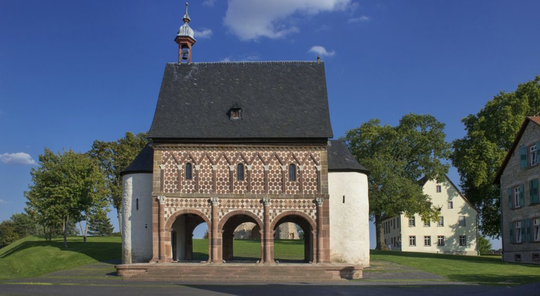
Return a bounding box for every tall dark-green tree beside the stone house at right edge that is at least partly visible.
[451,76,540,237]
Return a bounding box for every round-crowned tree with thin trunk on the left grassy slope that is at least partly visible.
[25,148,104,248]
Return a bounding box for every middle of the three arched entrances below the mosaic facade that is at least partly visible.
[218,211,262,262]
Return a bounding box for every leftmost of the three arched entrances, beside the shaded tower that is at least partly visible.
[166,210,210,262]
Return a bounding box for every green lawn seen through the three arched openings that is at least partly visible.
[193,239,304,260]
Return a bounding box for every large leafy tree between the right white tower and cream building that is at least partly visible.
[346,114,450,250]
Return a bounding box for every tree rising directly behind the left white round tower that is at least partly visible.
[90,132,148,231]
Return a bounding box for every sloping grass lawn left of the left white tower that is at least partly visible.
[0,236,122,280]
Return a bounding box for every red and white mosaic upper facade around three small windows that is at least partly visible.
[160,147,324,195]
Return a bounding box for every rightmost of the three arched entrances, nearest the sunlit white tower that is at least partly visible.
[272,211,315,263]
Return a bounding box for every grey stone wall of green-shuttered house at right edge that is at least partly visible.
[500,122,540,264]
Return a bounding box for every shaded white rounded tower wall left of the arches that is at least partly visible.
[122,174,152,263]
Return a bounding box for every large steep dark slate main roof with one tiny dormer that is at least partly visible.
[148,62,333,140]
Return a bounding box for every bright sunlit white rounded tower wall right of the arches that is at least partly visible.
[328,172,370,266]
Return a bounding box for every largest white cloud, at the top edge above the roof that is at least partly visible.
[223,0,351,41]
